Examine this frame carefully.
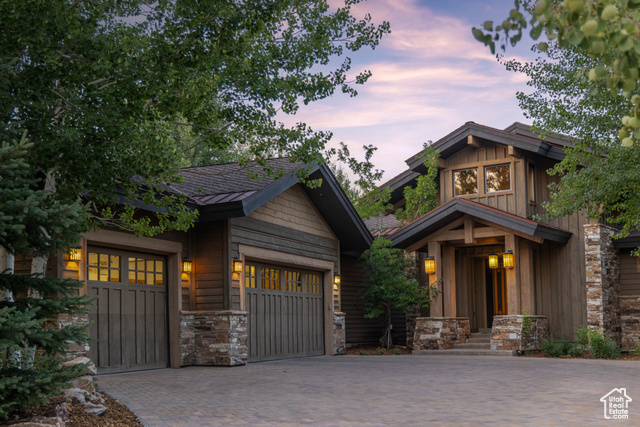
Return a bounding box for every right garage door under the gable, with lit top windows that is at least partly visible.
[245,262,324,362]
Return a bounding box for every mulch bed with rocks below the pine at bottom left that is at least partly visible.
[0,393,143,427]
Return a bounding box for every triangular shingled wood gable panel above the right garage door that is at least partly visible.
[249,184,336,239]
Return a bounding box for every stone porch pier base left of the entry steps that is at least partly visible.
[413,317,471,350]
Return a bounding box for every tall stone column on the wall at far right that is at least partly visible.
[584,224,621,344]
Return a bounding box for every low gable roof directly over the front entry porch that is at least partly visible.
[390,197,572,248]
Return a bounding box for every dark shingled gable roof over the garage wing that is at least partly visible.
[172,158,373,255]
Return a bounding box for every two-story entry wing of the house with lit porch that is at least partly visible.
[343,122,640,350]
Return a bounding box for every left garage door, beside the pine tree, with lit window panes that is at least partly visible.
[86,247,167,373]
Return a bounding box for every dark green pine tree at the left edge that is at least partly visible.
[0,134,90,419]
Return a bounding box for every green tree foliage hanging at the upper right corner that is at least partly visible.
[473,0,640,241]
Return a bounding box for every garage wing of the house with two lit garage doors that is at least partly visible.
[57,159,372,373]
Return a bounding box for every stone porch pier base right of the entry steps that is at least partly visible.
[491,314,549,351]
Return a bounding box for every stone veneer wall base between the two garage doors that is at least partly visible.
[180,310,247,366]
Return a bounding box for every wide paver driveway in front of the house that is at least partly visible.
[98,356,640,426]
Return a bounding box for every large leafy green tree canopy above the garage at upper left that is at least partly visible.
[0,0,389,234]
